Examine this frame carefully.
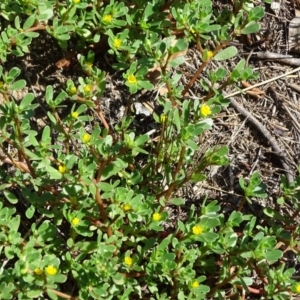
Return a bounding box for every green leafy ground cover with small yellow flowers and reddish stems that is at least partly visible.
[0,0,300,300]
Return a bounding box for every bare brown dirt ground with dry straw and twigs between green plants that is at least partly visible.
[0,0,300,298]
